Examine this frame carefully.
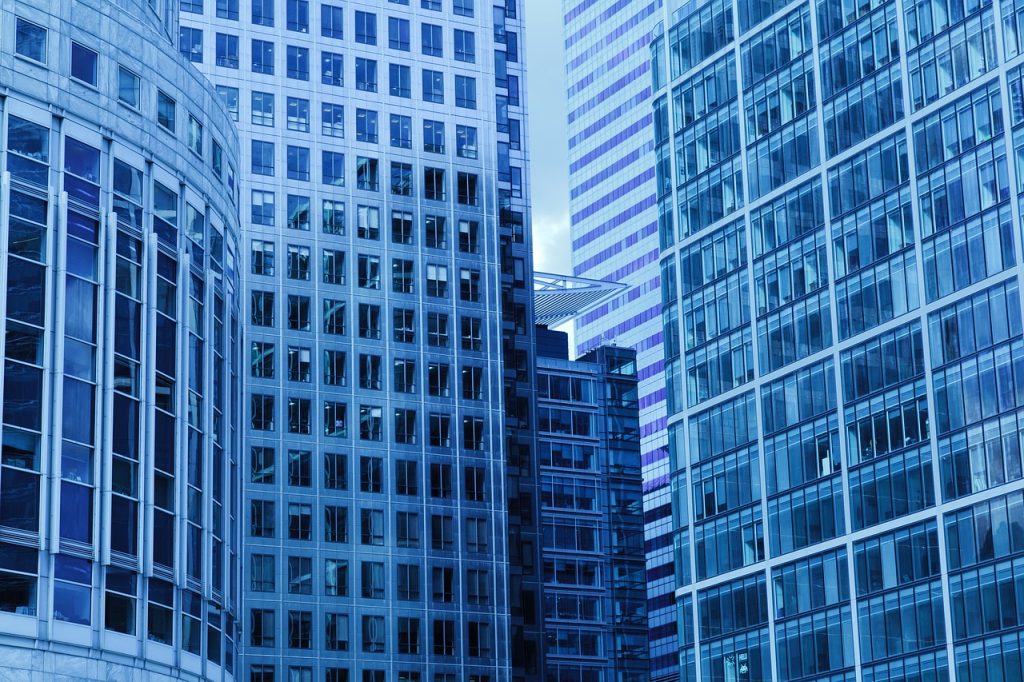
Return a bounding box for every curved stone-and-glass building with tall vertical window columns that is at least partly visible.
[0,0,241,680]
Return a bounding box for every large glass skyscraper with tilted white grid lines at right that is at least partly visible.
[651,0,1024,682]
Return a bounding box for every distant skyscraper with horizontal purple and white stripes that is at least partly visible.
[562,0,677,679]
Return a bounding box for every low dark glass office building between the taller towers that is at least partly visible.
[537,327,648,682]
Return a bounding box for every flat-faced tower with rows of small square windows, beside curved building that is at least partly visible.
[179,0,540,682]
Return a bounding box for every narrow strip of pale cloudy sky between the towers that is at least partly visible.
[523,0,572,274]
